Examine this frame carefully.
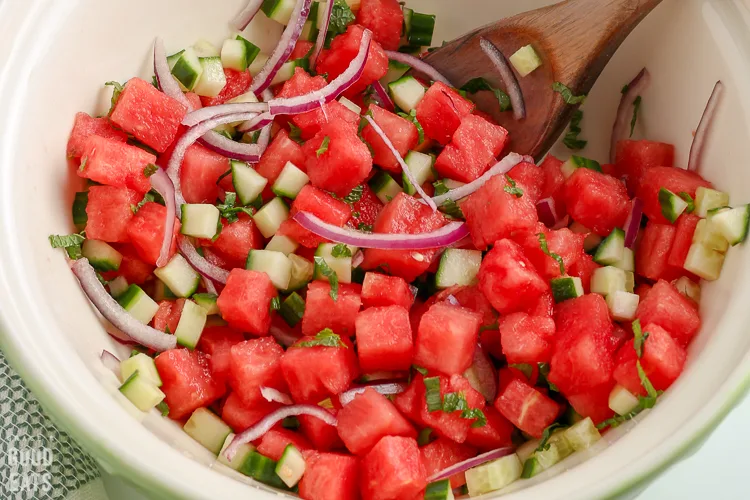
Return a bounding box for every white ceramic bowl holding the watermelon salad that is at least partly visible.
[0,0,750,499]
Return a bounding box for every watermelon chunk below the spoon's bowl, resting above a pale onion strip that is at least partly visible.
[435,114,508,182]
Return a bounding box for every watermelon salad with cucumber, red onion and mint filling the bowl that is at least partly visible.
[50,0,750,500]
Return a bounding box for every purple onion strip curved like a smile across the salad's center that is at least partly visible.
[292,212,469,250]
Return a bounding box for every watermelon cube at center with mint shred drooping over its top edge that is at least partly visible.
[302,281,362,337]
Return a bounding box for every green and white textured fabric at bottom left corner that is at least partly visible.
[0,352,106,500]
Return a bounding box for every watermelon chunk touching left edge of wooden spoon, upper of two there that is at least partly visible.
[417,82,476,145]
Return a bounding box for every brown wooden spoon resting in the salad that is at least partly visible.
[425,0,662,160]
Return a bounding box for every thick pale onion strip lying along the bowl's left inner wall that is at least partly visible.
[70,258,177,351]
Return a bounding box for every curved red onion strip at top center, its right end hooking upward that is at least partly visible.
[268,29,372,116]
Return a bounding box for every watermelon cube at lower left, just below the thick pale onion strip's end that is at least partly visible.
[154,349,225,420]
